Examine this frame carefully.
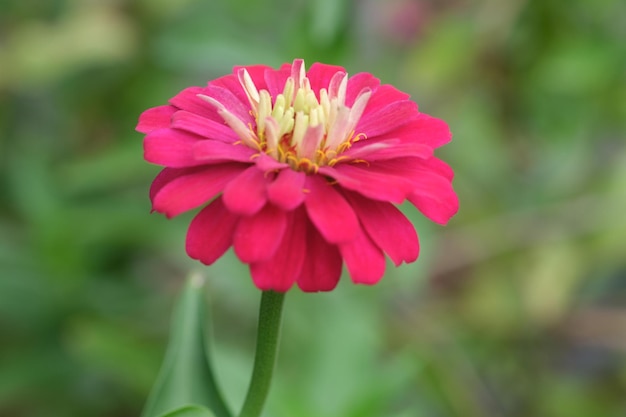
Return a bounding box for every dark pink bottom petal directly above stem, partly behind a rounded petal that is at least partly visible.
[250,209,307,292]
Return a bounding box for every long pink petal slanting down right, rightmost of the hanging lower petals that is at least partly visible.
[345,193,419,266]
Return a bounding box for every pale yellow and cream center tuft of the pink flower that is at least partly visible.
[199,60,371,172]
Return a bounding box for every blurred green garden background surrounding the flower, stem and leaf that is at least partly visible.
[0,0,626,417]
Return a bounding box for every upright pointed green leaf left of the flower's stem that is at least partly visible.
[142,275,231,417]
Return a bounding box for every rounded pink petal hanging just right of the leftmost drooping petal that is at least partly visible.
[234,204,287,263]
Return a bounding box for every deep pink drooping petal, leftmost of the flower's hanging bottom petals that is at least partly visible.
[186,198,239,265]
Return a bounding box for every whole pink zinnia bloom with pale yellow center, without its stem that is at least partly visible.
[137,60,458,292]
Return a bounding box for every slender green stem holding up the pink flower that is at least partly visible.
[239,291,285,417]
